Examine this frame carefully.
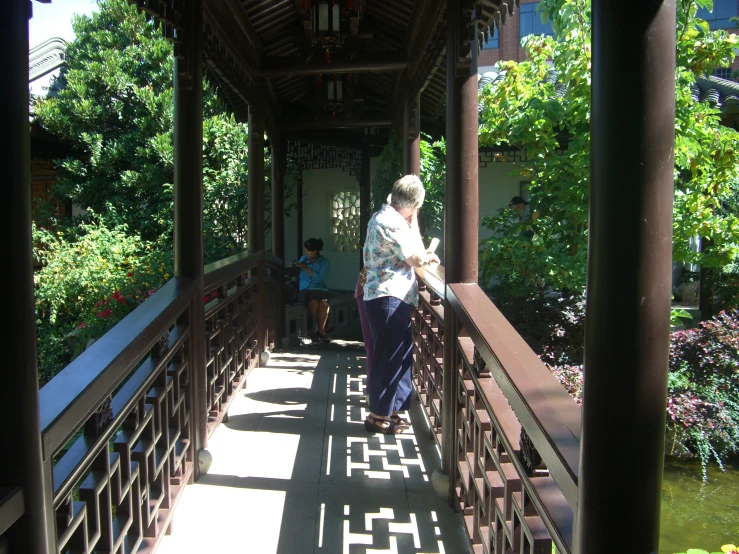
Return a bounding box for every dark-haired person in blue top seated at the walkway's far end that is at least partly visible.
[295,238,331,342]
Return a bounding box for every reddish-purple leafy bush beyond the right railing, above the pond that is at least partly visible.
[490,282,739,479]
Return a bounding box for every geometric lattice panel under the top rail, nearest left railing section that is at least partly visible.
[53,325,193,554]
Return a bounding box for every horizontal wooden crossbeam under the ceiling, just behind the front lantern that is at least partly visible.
[261,53,408,78]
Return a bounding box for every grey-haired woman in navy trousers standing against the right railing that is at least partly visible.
[363,175,439,434]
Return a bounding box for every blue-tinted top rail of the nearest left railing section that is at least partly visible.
[39,277,194,459]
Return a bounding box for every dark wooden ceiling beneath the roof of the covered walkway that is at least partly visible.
[53,0,518,142]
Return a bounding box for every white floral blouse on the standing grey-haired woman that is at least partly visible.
[363,204,423,306]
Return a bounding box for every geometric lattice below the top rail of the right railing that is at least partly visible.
[413,270,573,554]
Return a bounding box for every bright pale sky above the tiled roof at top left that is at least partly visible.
[28,0,97,94]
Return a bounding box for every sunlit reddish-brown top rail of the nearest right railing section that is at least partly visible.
[447,283,582,511]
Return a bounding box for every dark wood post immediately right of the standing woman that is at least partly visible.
[442,0,478,493]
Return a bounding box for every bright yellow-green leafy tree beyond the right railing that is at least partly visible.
[480,0,739,291]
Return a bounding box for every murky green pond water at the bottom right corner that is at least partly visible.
[659,458,739,554]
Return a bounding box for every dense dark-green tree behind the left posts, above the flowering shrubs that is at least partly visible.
[34,0,269,254]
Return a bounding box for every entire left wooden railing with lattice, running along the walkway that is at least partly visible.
[34,252,282,553]
